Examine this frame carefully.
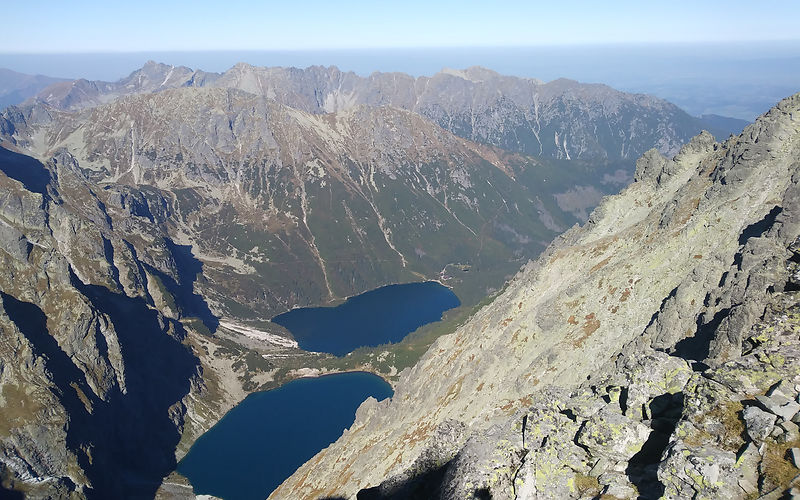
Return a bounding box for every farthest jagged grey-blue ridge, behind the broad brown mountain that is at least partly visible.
[23,62,702,160]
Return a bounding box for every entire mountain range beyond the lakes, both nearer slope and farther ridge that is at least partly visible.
[0,58,724,319]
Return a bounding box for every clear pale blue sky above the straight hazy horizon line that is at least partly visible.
[6,0,800,53]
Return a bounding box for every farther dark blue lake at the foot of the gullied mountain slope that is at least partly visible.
[272,281,461,356]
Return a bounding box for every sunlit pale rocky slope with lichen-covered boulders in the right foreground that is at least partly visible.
[272,95,800,498]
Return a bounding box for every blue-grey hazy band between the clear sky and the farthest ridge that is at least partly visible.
[0,42,800,120]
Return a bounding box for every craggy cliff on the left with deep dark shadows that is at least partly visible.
[0,145,202,498]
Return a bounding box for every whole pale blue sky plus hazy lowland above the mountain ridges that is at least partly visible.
[0,0,800,120]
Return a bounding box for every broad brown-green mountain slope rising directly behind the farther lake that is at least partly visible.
[0,88,627,318]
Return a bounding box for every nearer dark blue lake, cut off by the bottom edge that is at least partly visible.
[178,372,392,500]
